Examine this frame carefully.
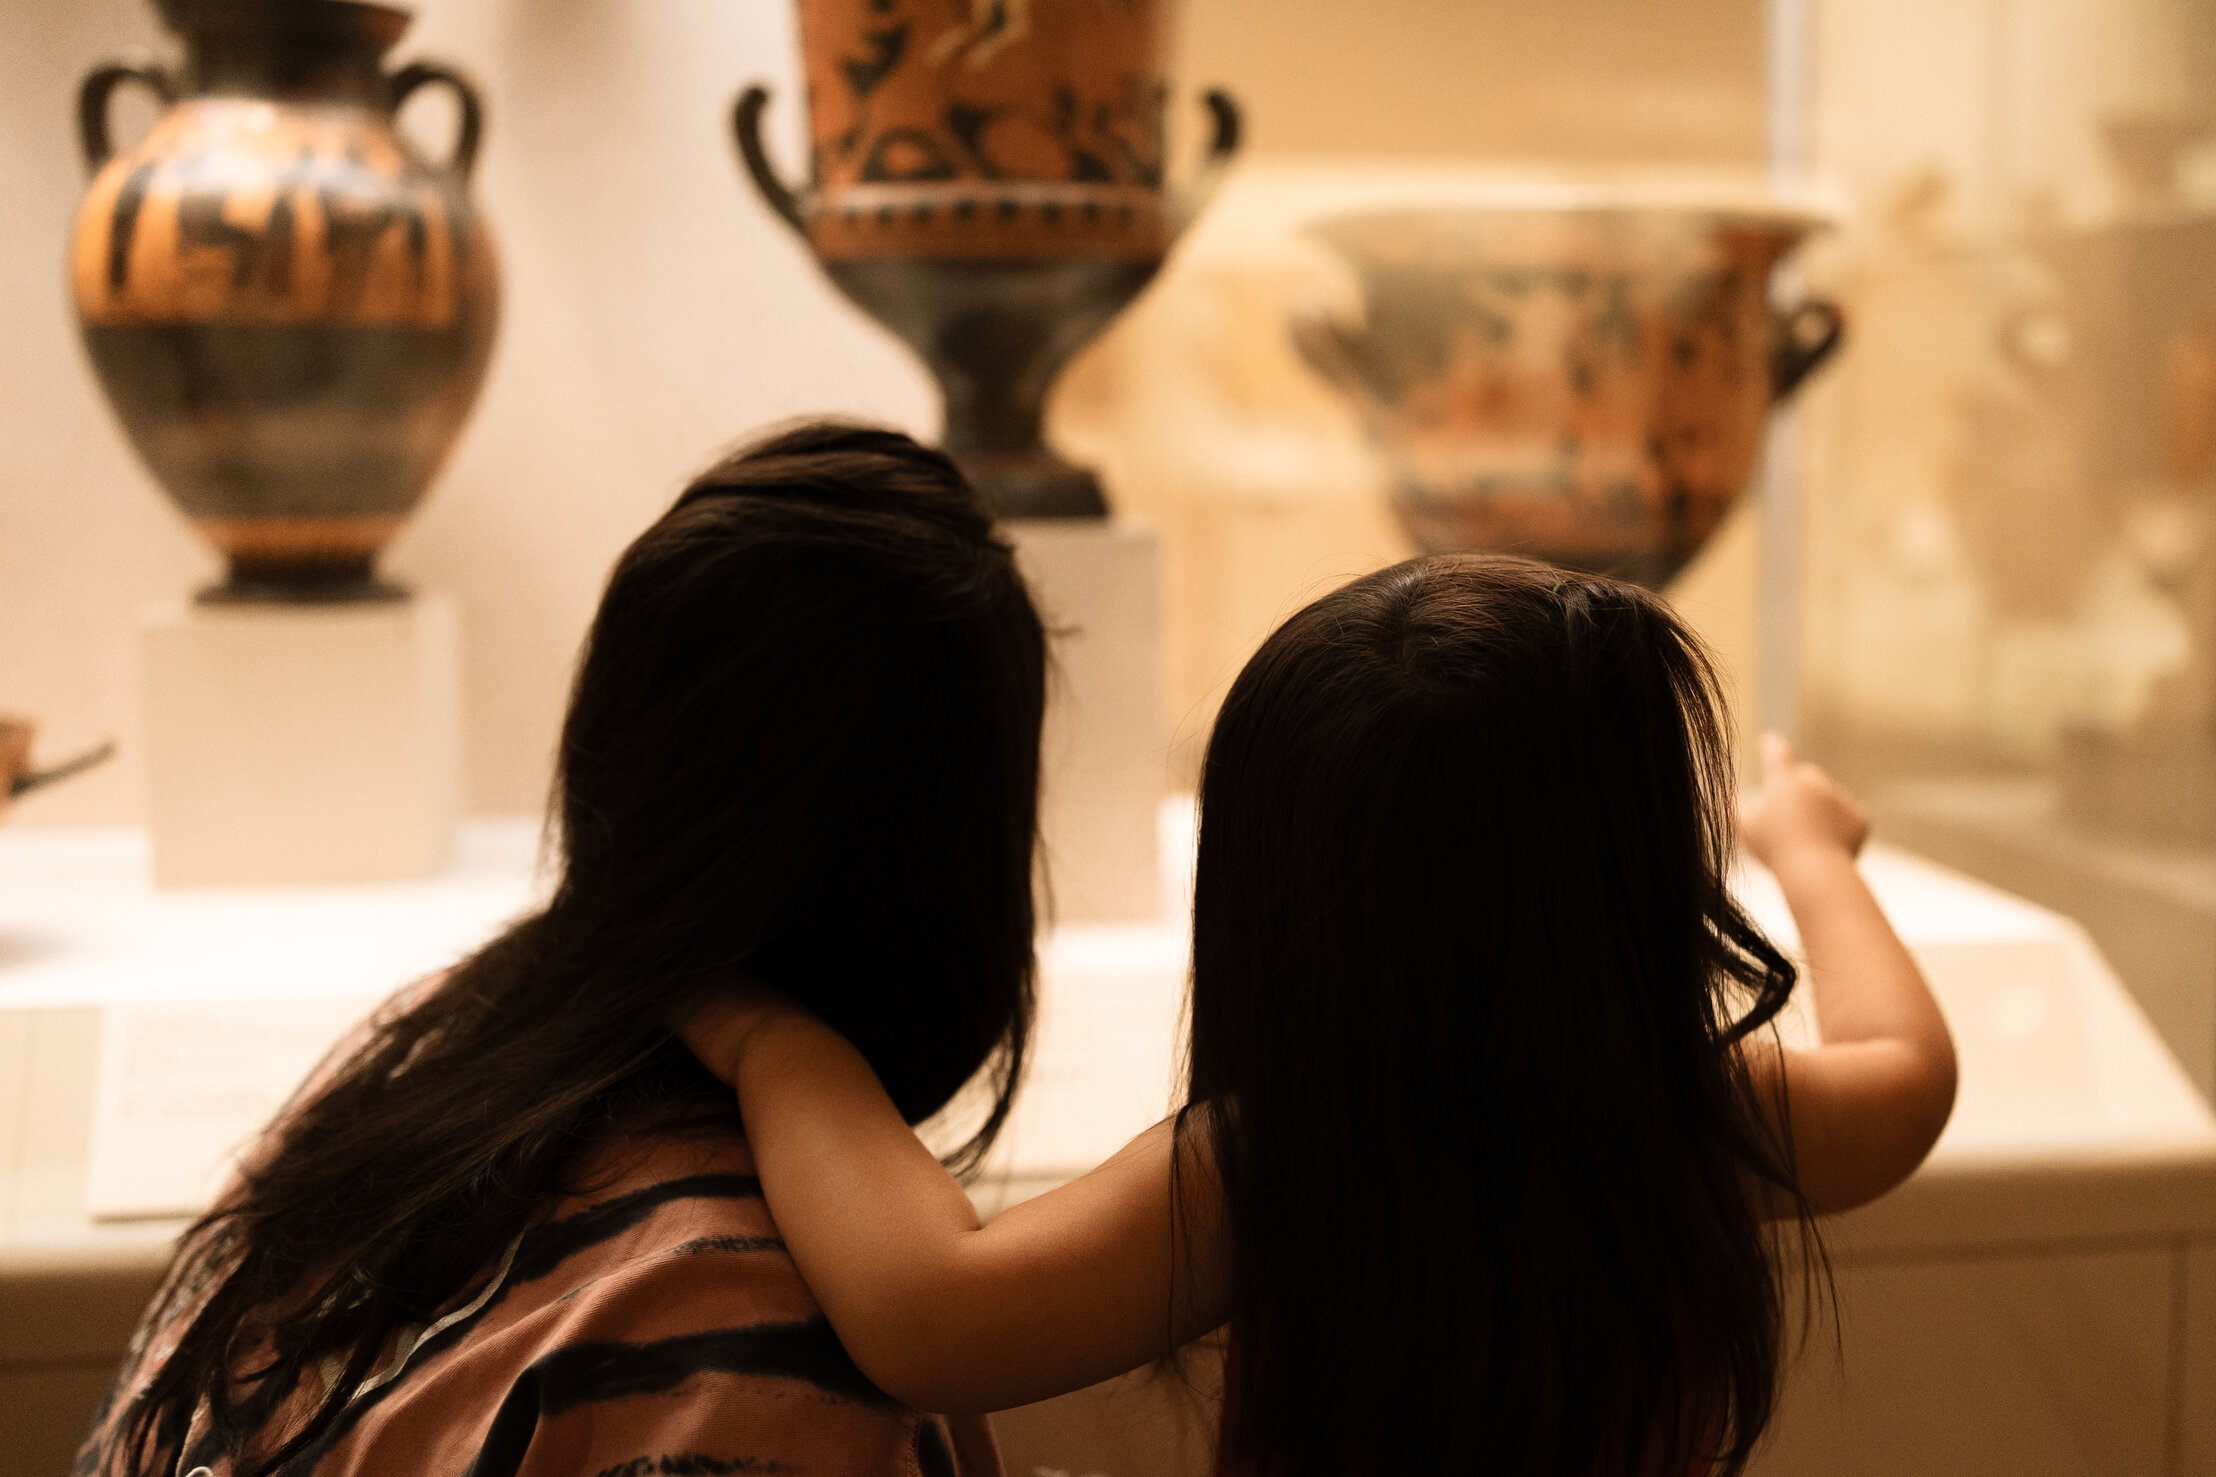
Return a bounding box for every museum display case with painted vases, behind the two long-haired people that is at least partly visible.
[0,0,2216,1477]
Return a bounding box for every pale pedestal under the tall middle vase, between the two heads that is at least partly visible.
[1004,520,1168,923]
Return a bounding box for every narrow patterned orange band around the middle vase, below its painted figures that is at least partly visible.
[807,182,1172,261]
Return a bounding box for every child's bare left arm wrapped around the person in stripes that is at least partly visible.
[683,992,1225,1415]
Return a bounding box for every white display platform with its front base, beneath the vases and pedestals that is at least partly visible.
[0,802,2216,1477]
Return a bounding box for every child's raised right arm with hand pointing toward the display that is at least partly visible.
[1740,735,1955,1211]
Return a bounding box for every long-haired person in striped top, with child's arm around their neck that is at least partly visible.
[78,425,1046,1477]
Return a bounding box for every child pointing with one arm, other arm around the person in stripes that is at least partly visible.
[687,556,1955,1477]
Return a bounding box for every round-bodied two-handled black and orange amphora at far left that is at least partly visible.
[71,0,499,600]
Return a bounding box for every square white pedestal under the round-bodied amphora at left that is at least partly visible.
[140,593,461,888]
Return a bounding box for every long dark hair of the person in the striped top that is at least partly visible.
[120,425,1046,1477]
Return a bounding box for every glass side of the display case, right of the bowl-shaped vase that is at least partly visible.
[1797,0,2216,1094]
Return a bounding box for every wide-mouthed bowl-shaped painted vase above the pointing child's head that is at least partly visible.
[1292,208,1841,587]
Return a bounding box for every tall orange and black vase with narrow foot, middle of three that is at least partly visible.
[733,0,1239,518]
